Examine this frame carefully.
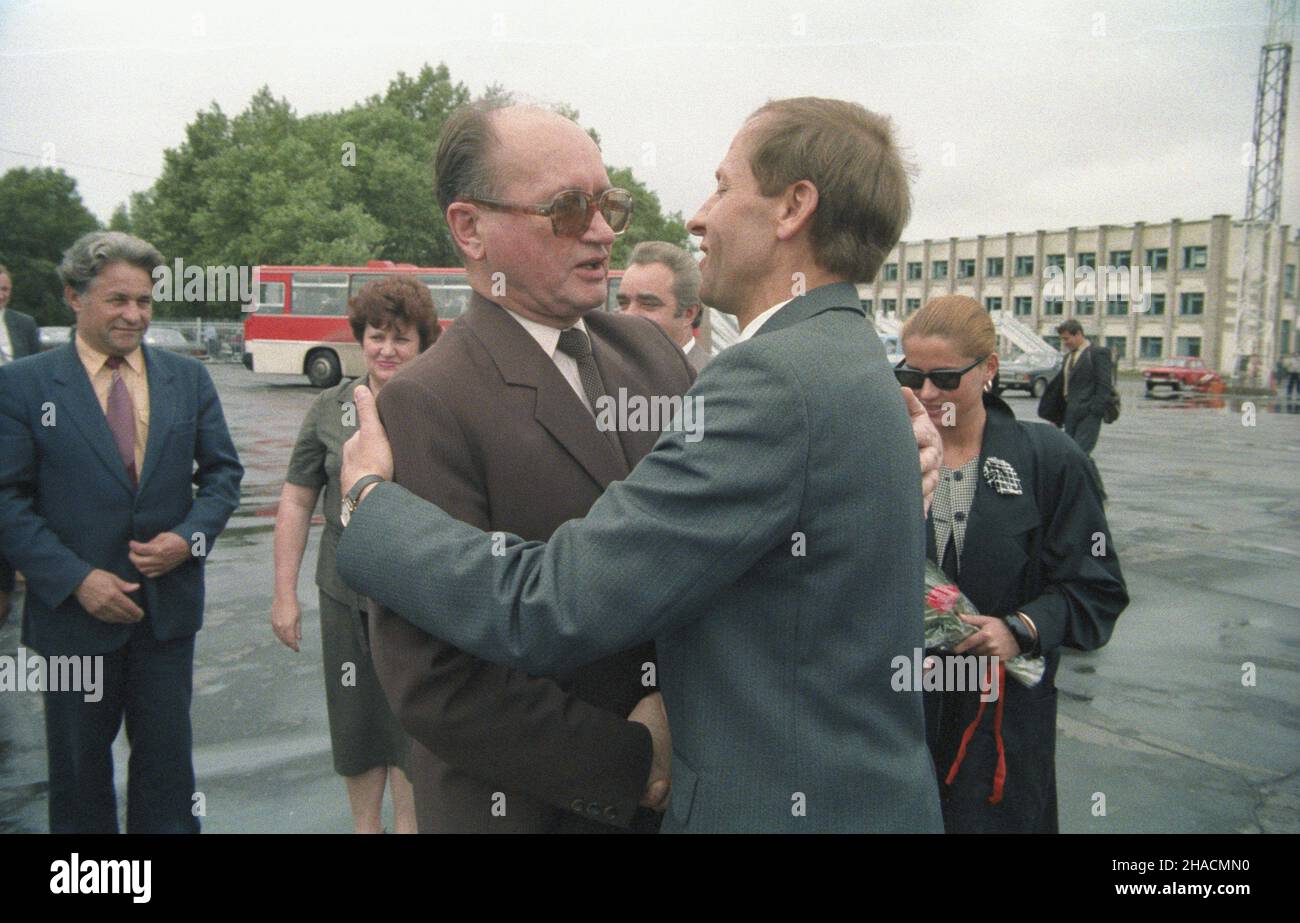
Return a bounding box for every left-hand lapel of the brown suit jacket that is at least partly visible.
[464,293,628,490]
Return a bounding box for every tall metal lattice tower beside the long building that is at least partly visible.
[1232,0,1296,387]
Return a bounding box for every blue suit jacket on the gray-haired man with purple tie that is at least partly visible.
[0,343,243,655]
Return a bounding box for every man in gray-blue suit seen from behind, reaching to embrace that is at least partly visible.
[339,99,943,832]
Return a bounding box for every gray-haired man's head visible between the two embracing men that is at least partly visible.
[619,241,712,372]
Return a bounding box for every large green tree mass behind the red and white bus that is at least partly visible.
[126,64,686,317]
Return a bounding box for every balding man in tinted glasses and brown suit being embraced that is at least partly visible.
[356,108,693,833]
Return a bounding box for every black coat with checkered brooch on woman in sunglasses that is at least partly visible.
[926,394,1128,833]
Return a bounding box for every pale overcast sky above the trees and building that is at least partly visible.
[0,0,1300,241]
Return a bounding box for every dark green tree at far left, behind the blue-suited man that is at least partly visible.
[0,166,99,325]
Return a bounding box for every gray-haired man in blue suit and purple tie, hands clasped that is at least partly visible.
[0,231,243,833]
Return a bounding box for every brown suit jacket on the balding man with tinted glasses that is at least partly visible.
[371,295,694,833]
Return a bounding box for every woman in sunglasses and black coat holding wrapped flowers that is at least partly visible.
[894,295,1128,833]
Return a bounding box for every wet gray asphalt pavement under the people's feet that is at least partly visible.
[0,365,1300,833]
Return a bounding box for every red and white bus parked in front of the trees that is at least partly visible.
[243,260,623,387]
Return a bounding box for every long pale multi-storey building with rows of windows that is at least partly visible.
[858,215,1300,376]
